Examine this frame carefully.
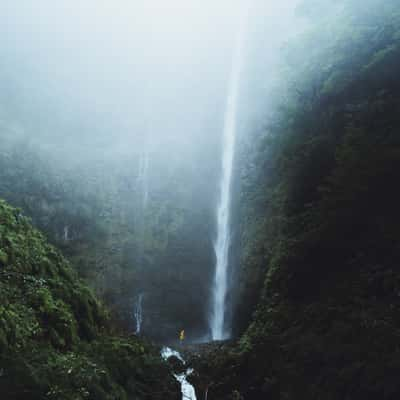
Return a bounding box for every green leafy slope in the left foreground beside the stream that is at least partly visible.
[0,201,179,400]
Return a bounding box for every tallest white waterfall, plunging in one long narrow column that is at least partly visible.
[210,10,247,340]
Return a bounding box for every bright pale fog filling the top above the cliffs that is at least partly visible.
[0,0,302,161]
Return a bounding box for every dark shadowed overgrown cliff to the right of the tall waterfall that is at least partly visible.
[198,1,400,400]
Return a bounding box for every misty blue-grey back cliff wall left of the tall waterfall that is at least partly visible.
[0,138,215,340]
